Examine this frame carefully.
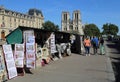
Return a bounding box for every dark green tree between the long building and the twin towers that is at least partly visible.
[41,21,59,31]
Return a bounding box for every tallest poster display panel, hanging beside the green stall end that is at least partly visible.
[24,30,36,68]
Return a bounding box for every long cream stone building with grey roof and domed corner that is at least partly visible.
[0,6,44,40]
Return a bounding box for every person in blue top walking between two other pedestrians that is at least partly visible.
[91,36,99,55]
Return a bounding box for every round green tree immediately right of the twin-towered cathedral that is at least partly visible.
[84,24,100,36]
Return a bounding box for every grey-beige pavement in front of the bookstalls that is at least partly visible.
[7,41,115,82]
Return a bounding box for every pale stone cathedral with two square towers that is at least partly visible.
[61,10,84,35]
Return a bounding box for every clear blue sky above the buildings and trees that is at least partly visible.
[0,0,120,33]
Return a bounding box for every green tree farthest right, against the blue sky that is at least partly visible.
[102,23,119,35]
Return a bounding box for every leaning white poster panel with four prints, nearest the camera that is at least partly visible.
[2,45,17,79]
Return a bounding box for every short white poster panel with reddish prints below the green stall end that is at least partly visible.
[14,44,24,68]
